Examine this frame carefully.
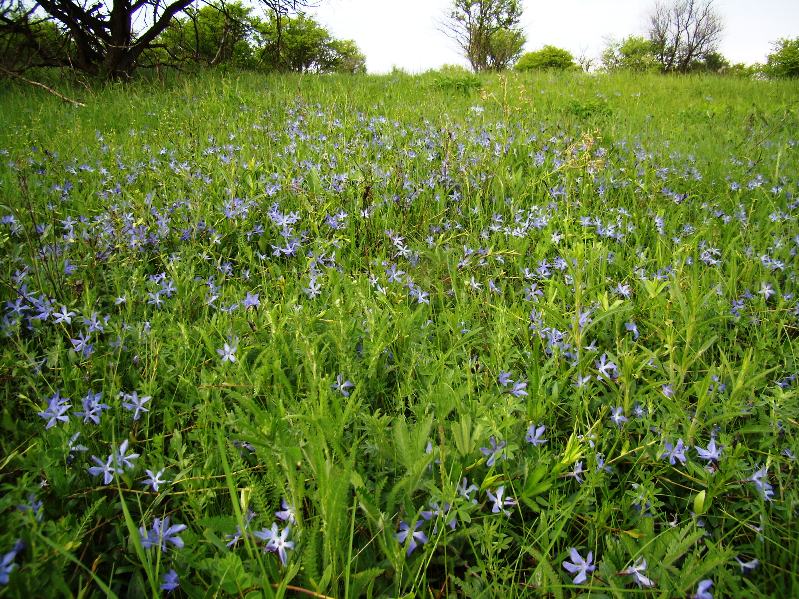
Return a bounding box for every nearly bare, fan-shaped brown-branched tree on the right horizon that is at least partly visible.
[649,0,724,73]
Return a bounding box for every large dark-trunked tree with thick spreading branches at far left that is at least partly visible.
[0,0,322,78]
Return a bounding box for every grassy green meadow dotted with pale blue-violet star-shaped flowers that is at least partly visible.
[0,72,799,599]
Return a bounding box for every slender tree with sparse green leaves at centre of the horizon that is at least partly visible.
[442,0,525,72]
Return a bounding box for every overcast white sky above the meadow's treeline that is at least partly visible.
[308,0,799,73]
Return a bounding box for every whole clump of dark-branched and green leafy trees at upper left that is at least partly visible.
[0,0,365,78]
